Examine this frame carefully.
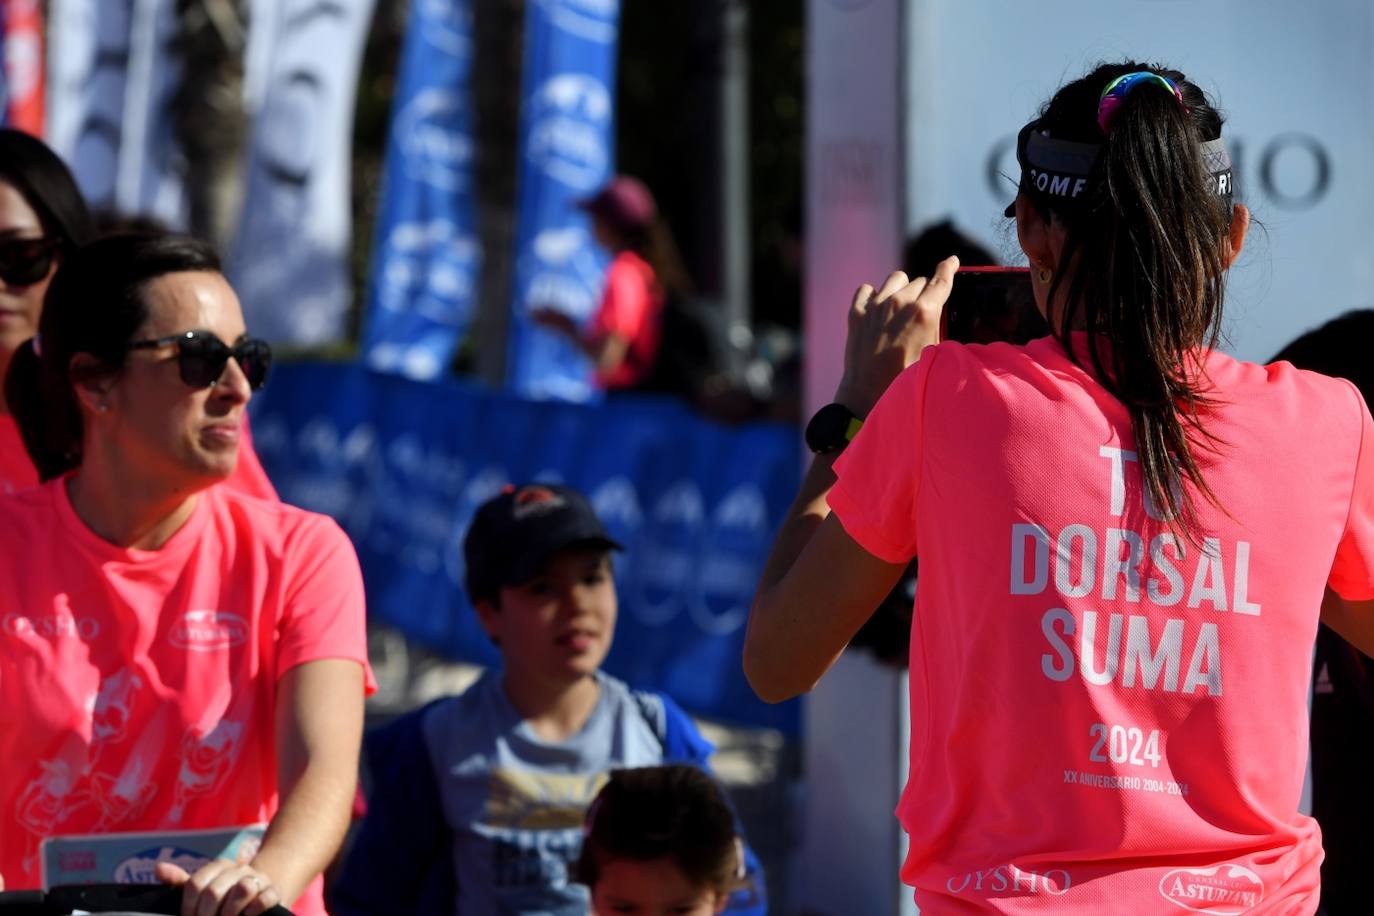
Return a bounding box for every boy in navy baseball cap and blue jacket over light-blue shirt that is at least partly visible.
[331,483,765,916]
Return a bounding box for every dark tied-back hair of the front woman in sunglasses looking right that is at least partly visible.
[4,235,220,481]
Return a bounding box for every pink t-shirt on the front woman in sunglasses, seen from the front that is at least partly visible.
[0,478,372,915]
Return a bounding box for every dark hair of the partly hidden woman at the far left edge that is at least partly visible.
[0,128,95,255]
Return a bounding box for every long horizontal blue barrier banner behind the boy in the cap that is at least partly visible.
[253,364,801,733]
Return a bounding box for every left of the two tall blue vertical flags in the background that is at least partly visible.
[363,0,481,379]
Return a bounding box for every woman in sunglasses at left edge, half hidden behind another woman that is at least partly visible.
[0,128,276,500]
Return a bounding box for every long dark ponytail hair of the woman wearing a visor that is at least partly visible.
[1032,62,1231,530]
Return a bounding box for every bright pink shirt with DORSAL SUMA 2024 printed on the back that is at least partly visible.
[830,338,1374,915]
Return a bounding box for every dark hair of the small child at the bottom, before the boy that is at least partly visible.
[576,764,746,893]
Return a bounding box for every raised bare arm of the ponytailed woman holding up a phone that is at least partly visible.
[745,258,959,702]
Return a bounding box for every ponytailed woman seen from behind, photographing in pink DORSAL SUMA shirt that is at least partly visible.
[745,63,1374,913]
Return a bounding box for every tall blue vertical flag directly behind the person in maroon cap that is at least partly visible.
[508,0,620,401]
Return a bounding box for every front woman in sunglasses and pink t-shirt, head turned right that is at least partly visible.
[0,235,371,916]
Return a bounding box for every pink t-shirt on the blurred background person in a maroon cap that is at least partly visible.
[589,251,664,389]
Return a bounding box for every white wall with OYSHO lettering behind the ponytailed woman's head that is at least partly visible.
[904,0,1374,360]
